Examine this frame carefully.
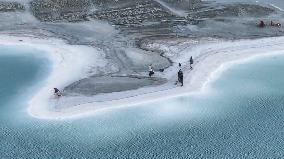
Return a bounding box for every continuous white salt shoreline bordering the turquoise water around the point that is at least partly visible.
[0,37,284,120]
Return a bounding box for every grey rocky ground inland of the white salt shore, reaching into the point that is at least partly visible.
[0,0,284,96]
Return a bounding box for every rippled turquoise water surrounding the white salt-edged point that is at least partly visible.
[0,45,284,159]
